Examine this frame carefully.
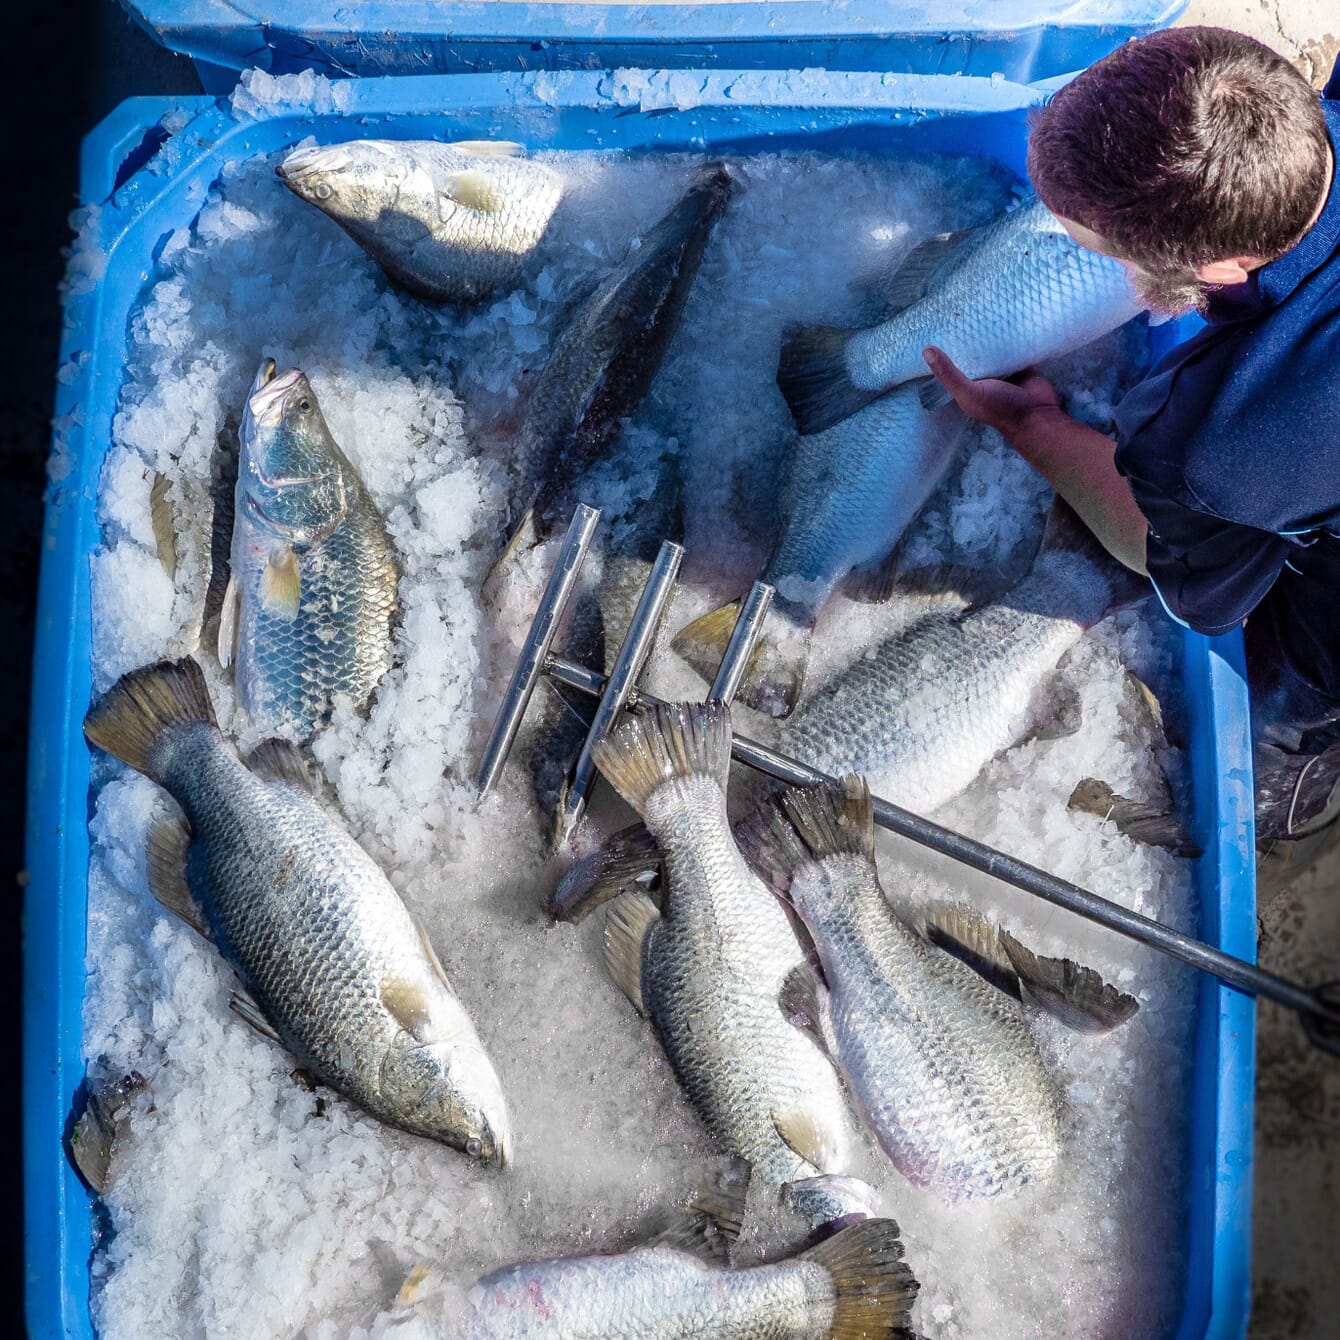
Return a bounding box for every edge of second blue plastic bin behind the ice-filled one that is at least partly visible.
[123,0,1187,92]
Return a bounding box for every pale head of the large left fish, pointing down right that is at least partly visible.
[381,1037,512,1168]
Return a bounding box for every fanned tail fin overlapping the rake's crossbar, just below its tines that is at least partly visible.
[592,702,730,815]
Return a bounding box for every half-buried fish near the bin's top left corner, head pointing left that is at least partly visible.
[276,139,563,303]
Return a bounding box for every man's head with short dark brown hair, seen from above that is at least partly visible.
[1028,28,1331,311]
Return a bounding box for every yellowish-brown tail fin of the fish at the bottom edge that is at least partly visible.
[803,1219,921,1340]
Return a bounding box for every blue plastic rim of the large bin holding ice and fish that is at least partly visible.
[24,60,1256,1340]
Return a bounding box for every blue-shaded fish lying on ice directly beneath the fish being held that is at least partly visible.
[673,387,965,717]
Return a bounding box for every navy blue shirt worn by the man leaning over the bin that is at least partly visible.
[1116,90,1340,701]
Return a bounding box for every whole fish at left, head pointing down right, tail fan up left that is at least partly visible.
[84,659,509,1164]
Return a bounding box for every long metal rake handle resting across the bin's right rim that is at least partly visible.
[548,658,1340,1034]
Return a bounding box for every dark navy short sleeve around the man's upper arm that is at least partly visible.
[1130,478,1289,637]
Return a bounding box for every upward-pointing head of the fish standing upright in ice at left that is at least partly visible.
[237,359,348,544]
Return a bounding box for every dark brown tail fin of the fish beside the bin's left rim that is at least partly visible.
[84,657,214,781]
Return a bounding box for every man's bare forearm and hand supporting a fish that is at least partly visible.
[925,348,1148,575]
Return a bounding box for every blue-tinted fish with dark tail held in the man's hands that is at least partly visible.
[777,198,1144,433]
